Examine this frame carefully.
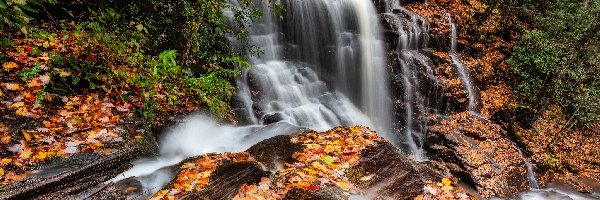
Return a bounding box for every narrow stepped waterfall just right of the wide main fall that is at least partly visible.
[385,5,439,160]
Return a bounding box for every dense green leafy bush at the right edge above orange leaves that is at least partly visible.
[509,0,600,126]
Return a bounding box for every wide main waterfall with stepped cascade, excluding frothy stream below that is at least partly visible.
[238,0,391,132]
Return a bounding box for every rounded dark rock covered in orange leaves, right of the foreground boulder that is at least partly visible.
[426,113,528,197]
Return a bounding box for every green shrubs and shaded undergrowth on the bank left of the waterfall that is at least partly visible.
[0,0,261,121]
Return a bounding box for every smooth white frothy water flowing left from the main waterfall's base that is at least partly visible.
[111,114,299,198]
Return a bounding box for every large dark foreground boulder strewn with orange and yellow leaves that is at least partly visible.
[143,126,466,199]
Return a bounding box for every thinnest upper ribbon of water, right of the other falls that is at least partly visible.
[448,14,479,115]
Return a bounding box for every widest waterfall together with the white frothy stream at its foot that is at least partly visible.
[113,0,392,197]
